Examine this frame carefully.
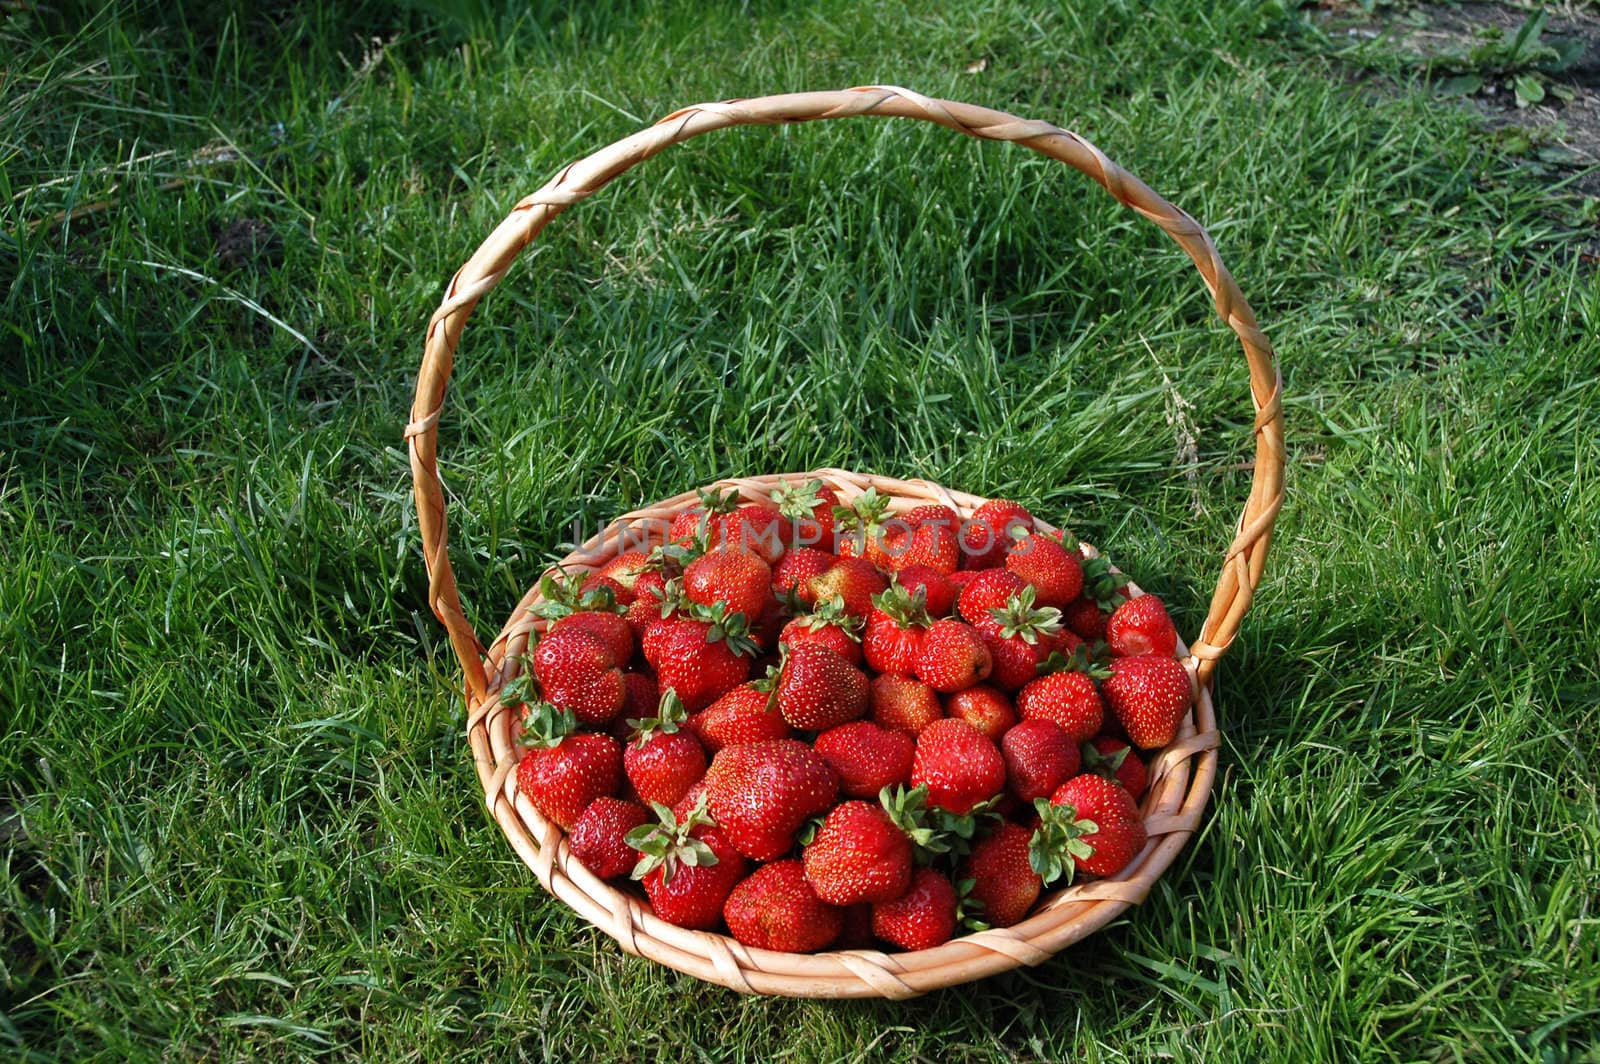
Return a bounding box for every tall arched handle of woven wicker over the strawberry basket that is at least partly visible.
[405,85,1283,704]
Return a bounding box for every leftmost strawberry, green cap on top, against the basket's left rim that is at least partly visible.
[517,702,622,830]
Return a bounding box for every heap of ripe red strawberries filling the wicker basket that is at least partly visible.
[501,482,1190,952]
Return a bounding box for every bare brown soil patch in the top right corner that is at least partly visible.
[1330,3,1600,197]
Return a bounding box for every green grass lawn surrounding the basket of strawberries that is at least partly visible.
[0,0,1600,1061]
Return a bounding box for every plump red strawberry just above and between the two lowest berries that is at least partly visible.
[800,802,912,906]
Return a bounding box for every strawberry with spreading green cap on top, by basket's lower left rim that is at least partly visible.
[627,805,747,931]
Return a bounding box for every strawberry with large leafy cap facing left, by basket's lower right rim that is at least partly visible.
[1029,773,1146,883]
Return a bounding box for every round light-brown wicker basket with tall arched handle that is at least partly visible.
[406,86,1283,998]
